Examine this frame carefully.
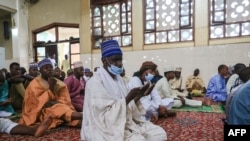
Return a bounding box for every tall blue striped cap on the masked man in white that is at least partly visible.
[101,40,122,58]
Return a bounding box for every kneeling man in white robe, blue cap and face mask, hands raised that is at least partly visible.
[80,40,167,141]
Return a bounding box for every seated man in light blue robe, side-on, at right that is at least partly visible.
[206,64,228,105]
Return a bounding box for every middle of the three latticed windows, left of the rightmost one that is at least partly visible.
[144,0,194,44]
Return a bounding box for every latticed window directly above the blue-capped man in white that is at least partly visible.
[91,0,132,48]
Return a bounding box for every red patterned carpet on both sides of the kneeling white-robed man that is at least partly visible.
[0,111,224,141]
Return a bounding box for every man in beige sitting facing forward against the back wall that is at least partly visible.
[186,69,206,96]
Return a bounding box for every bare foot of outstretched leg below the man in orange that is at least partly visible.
[34,117,52,137]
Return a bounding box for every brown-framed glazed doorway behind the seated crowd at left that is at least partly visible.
[32,23,80,67]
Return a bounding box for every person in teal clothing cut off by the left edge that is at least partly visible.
[0,70,14,117]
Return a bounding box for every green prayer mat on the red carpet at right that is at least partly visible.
[171,105,225,113]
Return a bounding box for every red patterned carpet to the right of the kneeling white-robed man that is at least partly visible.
[156,112,224,141]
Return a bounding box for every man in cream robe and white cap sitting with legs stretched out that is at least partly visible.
[155,66,202,107]
